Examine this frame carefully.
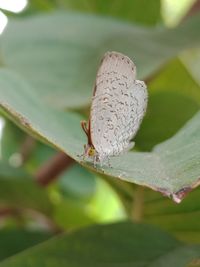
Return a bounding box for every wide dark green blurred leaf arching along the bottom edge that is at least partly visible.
[0,223,200,267]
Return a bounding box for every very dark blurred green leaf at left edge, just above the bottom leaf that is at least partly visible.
[0,229,52,261]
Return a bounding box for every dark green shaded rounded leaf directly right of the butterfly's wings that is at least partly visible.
[135,91,200,151]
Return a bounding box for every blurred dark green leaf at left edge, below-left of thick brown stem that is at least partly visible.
[0,163,52,214]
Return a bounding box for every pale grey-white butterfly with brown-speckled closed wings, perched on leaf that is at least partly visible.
[81,52,148,165]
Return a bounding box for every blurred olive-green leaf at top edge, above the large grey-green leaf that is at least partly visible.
[55,0,161,25]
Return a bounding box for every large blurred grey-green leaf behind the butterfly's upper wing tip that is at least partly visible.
[1,12,200,107]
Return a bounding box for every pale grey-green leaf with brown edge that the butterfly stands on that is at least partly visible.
[0,71,200,202]
